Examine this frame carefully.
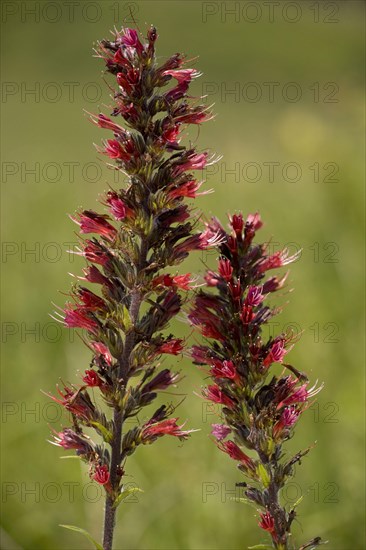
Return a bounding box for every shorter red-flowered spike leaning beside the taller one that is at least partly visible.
[189,214,321,550]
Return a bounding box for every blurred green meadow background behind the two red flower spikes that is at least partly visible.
[1,1,365,550]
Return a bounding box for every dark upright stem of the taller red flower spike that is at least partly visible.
[103,240,148,550]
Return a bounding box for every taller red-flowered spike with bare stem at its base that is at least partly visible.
[48,27,219,550]
